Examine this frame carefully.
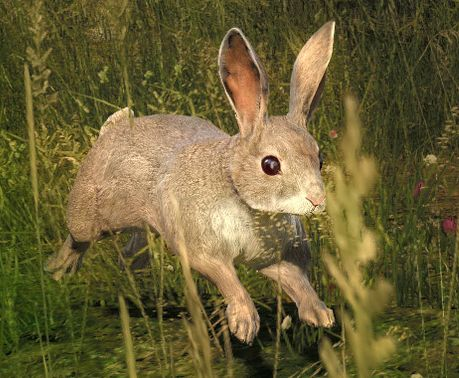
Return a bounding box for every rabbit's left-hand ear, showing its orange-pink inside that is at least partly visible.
[218,28,268,137]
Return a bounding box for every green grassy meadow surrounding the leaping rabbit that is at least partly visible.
[0,0,459,378]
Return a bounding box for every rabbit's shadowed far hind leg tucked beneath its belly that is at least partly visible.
[119,230,150,271]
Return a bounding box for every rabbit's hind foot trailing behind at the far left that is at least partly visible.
[45,234,90,281]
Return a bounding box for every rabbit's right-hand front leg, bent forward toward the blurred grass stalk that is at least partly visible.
[260,261,335,328]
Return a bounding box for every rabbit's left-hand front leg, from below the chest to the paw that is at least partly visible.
[190,256,260,344]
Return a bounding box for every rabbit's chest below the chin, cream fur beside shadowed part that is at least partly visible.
[212,204,300,269]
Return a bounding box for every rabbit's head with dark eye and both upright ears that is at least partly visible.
[219,22,335,214]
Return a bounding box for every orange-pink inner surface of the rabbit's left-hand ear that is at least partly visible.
[224,34,260,123]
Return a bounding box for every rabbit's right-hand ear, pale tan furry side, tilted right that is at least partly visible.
[287,21,335,126]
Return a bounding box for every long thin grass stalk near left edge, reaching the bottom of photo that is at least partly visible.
[24,64,51,377]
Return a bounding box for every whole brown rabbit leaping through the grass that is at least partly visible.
[47,22,335,344]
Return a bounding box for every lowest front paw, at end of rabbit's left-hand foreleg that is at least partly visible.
[226,301,260,344]
